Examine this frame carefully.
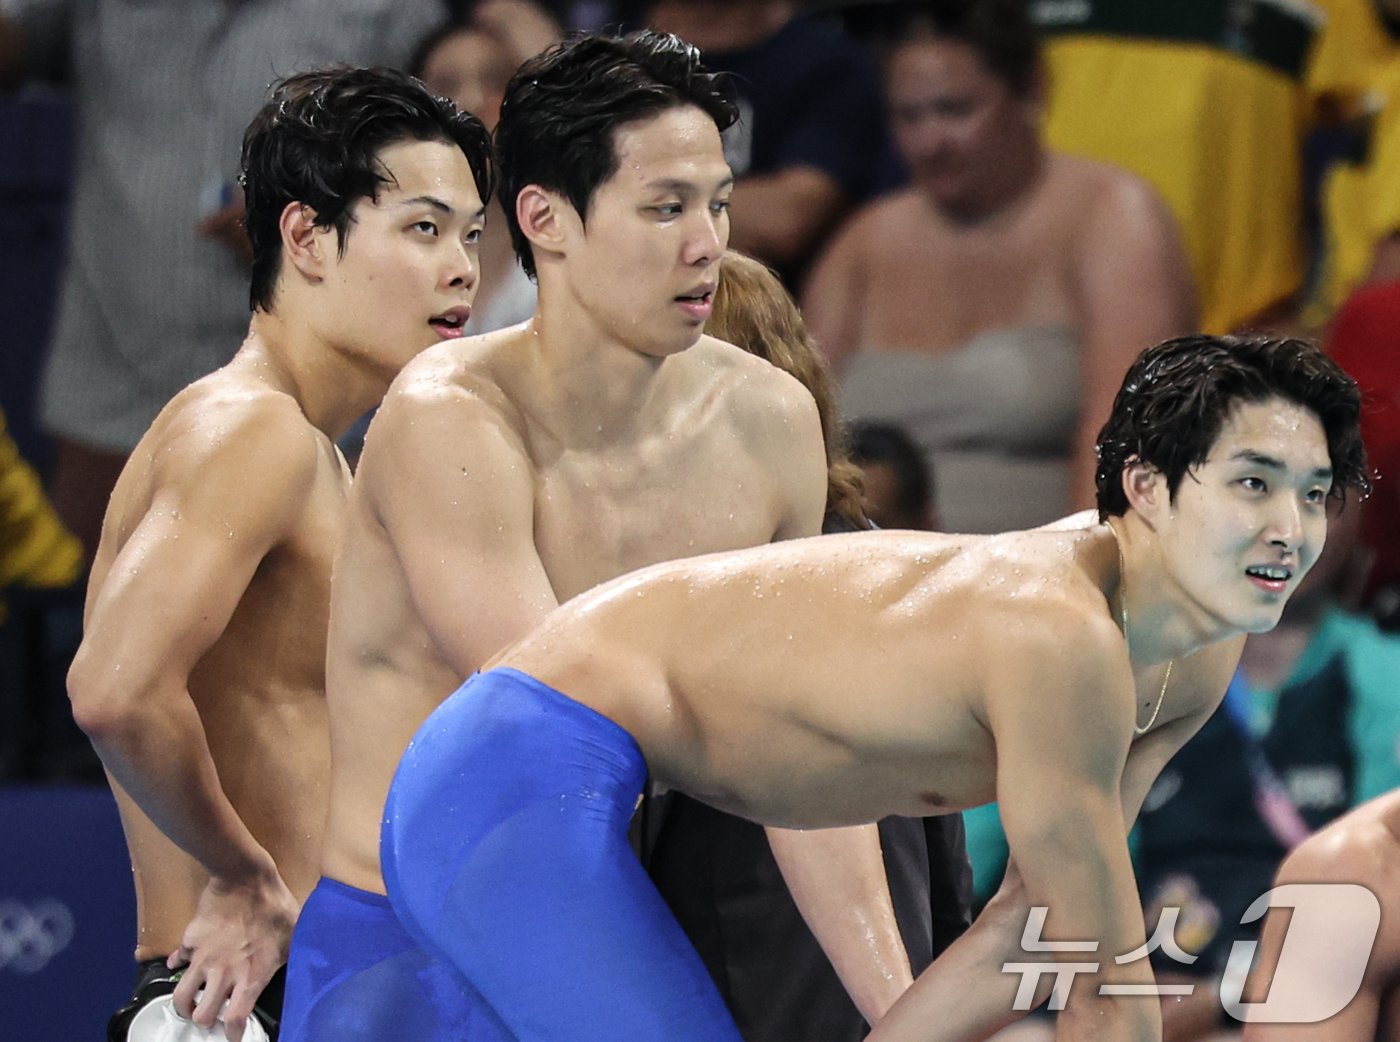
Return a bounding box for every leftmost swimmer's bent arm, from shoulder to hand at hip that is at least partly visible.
[69,408,318,1036]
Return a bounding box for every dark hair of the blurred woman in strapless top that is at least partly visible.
[874,0,1040,97]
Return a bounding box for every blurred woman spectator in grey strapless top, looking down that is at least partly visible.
[804,0,1194,532]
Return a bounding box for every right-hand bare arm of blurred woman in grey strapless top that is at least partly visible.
[1067,172,1197,510]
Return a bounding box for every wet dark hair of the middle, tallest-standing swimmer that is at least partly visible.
[496,31,739,277]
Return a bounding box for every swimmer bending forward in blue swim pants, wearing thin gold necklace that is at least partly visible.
[384,336,1369,1042]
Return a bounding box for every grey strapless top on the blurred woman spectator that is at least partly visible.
[841,326,1079,532]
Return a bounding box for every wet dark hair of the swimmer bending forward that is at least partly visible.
[1095,335,1371,520]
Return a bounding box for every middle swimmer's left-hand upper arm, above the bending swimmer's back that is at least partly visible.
[360,384,557,680]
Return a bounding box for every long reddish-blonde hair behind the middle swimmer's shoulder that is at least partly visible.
[704,249,869,528]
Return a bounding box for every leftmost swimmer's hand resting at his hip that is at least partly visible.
[165,870,298,1042]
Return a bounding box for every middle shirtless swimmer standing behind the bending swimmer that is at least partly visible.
[283,32,910,1042]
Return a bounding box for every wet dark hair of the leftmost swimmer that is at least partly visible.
[238,66,491,311]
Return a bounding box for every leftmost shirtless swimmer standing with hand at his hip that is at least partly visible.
[69,69,490,1039]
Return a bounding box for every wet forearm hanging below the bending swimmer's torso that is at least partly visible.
[767,825,913,1024]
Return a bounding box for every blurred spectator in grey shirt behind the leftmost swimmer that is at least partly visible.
[0,0,442,550]
